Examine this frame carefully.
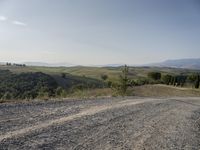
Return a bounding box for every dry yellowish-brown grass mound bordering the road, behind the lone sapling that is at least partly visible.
[50,84,200,98]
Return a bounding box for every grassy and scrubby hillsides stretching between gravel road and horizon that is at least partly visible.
[0,65,200,99]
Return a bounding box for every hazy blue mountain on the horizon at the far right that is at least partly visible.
[145,58,200,70]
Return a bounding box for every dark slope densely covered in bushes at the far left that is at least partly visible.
[0,70,58,99]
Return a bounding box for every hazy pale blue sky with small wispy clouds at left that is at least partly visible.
[0,0,200,65]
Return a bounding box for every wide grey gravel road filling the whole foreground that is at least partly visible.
[0,97,200,150]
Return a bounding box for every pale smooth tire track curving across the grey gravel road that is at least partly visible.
[0,99,155,142]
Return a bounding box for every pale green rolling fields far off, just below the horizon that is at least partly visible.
[0,66,199,80]
